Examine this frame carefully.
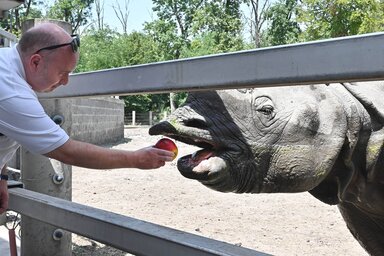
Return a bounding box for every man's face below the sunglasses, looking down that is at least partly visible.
[27,46,79,92]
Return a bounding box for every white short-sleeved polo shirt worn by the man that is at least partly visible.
[0,46,69,170]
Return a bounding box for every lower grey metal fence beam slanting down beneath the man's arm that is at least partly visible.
[9,188,268,256]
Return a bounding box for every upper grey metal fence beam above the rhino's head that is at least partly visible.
[39,33,384,98]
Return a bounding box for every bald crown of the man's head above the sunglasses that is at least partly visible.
[18,22,71,55]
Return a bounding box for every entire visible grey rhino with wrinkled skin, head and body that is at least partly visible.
[149,82,384,255]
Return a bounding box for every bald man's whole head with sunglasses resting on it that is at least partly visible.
[17,23,80,92]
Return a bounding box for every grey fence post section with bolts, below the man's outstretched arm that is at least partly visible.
[21,149,72,256]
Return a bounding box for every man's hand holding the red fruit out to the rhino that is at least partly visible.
[134,147,175,169]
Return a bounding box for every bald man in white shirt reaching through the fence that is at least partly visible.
[0,23,173,213]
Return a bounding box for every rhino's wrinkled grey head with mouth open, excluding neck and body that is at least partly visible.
[149,85,347,196]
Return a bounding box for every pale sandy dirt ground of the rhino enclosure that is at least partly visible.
[73,127,368,256]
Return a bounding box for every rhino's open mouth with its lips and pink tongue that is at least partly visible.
[149,121,225,181]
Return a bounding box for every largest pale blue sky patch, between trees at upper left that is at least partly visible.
[97,0,153,33]
